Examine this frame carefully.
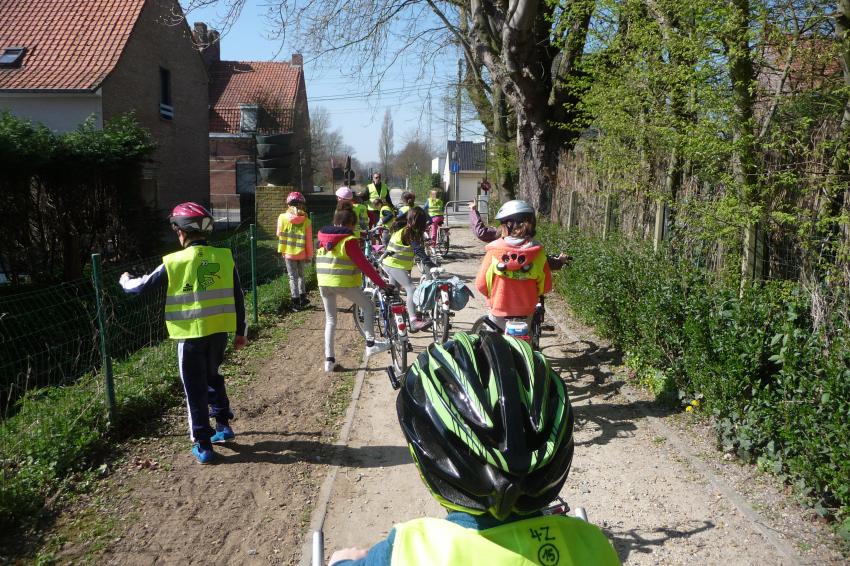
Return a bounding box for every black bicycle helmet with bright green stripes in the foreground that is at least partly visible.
[396,332,574,519]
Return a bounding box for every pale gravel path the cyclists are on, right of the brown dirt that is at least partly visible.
[316,230,841,564]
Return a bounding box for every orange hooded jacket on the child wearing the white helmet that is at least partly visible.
[475,238,552,316]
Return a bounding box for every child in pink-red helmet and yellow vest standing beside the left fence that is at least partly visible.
[277,191,313,310]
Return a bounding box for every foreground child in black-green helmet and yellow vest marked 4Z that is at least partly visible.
[329,332,620,566]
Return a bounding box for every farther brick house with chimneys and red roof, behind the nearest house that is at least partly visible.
[194,22,313,222]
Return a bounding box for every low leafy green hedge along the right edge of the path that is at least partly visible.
[540,225,850,517]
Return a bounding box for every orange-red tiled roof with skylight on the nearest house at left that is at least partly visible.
[0,0,145,90]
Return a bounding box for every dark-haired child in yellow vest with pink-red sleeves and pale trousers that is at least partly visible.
[316,202,390,372]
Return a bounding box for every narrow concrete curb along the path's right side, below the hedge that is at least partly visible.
[546,309,805,564]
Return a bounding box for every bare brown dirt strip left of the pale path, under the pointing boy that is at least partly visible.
[59,308,369,565]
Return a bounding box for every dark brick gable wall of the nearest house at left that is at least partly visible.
[103,0,210,214]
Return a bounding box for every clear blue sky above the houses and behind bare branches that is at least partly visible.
[183,0,483,162]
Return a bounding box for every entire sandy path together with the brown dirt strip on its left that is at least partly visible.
[51,230,841,565]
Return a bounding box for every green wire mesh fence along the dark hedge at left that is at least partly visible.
[0,213,331,418]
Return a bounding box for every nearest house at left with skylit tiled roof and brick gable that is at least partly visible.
[0,0,209,210]
